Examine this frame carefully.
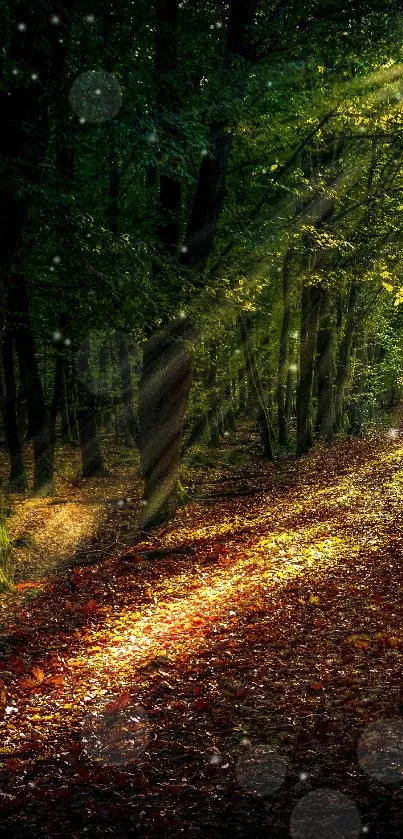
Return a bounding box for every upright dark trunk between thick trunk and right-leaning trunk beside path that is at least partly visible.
[316,288,334,443]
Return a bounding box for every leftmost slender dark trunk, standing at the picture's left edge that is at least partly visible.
[2,328,26,492]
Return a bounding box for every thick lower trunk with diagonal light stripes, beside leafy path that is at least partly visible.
[138,321,192,530]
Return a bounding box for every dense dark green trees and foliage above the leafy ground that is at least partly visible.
[0,0,403,540]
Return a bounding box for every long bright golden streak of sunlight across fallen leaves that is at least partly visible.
[0,436,401,752]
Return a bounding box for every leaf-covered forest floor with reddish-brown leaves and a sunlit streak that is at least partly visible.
[0,415,403,839]
